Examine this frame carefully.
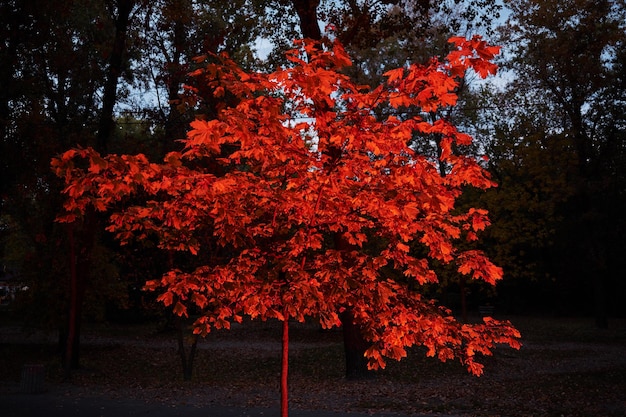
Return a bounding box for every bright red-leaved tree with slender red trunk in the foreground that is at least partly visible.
[53,37,519,415]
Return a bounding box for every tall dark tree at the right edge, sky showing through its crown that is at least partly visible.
[466,1,626,327]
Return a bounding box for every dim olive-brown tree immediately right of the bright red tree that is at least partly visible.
[466,88,574,313]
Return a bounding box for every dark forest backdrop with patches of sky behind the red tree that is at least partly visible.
[0,0,626,370]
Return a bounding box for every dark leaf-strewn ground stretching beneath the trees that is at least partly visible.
[0,317,626,417]
